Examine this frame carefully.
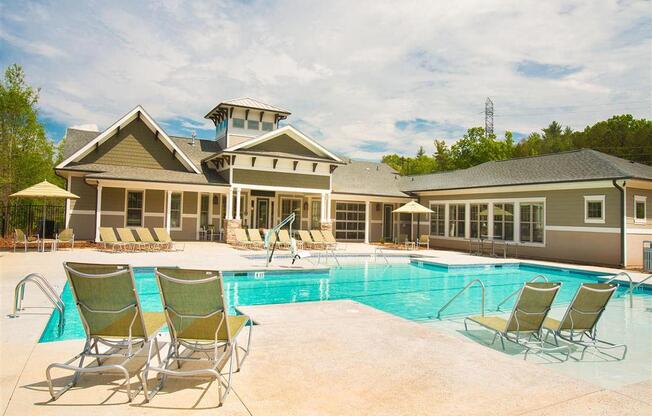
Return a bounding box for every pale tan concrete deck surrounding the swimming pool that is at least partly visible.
[0,243,652,415]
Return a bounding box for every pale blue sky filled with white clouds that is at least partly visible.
[0,0,652,160]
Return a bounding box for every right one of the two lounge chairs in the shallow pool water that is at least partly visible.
[543,283,627,360]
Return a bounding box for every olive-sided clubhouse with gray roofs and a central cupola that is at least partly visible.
[56,98,652,267]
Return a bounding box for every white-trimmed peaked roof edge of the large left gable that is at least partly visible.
[57,105,201,173]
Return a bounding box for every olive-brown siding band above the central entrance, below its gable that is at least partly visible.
[233,169,330,189]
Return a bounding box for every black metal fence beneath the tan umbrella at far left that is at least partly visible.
[0,203,66,238]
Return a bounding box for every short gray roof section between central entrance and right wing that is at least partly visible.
[333,160,407,197]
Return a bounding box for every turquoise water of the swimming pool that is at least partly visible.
[40,261,624,342]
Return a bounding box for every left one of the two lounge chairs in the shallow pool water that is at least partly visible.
[464,282,570,361]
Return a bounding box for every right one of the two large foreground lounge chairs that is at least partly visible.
[142,268,252,404]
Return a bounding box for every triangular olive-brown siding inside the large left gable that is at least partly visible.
[80,119,186,172]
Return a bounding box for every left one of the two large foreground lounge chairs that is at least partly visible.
[45,263,165,401]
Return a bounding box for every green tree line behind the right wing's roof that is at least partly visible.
[382,114,652,175]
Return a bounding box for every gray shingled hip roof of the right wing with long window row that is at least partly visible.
[401,149,652,192]
